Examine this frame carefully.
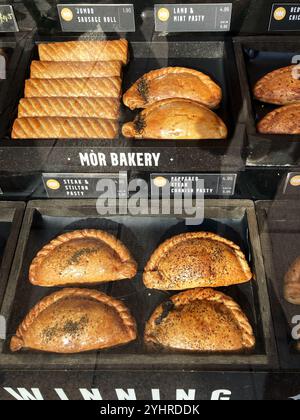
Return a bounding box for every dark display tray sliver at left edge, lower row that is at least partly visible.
[0,201,25,304]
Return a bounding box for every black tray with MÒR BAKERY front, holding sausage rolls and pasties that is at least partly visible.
[0,32,245,172]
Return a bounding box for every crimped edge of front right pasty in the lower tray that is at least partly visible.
[144,288,256,350]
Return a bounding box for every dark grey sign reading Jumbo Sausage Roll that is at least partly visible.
[57,4,135,32]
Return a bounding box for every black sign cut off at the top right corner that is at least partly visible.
[269,2,300,31]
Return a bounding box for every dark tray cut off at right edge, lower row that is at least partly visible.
[256,200,300,370]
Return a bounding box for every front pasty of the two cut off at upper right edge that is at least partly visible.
[257,103,300,134]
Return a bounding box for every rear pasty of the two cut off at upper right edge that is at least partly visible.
[254,66,300,105]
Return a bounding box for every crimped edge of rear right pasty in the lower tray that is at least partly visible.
[143,232,253,288]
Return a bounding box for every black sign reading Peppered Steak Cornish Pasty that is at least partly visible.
[151,174,237,196]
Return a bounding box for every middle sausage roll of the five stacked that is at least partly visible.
[25,77,122,98]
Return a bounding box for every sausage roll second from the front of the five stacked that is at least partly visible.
[18,97,120,120]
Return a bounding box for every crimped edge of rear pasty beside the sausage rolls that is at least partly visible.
[123,67,223,109]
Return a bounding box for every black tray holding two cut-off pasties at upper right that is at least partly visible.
[234,36,300,167]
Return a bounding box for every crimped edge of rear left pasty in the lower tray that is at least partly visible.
[29,229,137,286]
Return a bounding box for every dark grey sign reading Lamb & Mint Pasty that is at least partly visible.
[154,3,232,32]
